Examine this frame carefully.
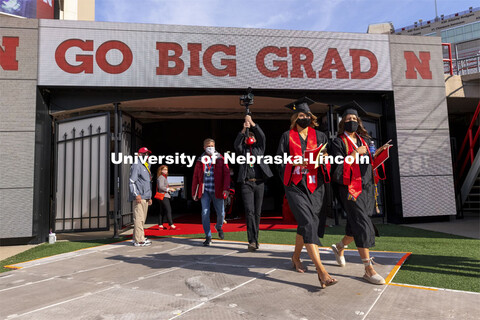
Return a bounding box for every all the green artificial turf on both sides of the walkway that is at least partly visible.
[0,225,480,292]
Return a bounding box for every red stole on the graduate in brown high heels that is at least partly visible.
[283,127,318,193]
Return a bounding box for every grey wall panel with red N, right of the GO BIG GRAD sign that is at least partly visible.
[390,36,456,217]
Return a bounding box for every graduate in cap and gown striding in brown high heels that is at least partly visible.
[277,97,337,288]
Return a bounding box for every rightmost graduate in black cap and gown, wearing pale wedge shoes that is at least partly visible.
[330,102,392,284]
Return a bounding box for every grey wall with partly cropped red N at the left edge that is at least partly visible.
[0,16,38,238]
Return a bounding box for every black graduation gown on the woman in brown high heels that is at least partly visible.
[277,130,327,245]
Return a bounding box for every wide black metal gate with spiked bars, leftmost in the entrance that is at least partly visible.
[53,113,110,232]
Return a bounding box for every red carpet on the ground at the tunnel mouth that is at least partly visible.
[145,216,297,237]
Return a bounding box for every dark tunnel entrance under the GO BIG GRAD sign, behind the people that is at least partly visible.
[44,88,398,236]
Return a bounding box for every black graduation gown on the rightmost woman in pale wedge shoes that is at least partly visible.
[329,137,376,248]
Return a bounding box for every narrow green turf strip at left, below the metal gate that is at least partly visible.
[0,238,124,273]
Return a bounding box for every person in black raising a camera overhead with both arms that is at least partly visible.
[235,115,273,252]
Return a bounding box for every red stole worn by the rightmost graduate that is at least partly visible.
[341,133,373,201]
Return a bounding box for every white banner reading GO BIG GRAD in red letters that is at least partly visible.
[38,20,392,91]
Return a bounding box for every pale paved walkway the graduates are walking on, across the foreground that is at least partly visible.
[0,238,480,320]
